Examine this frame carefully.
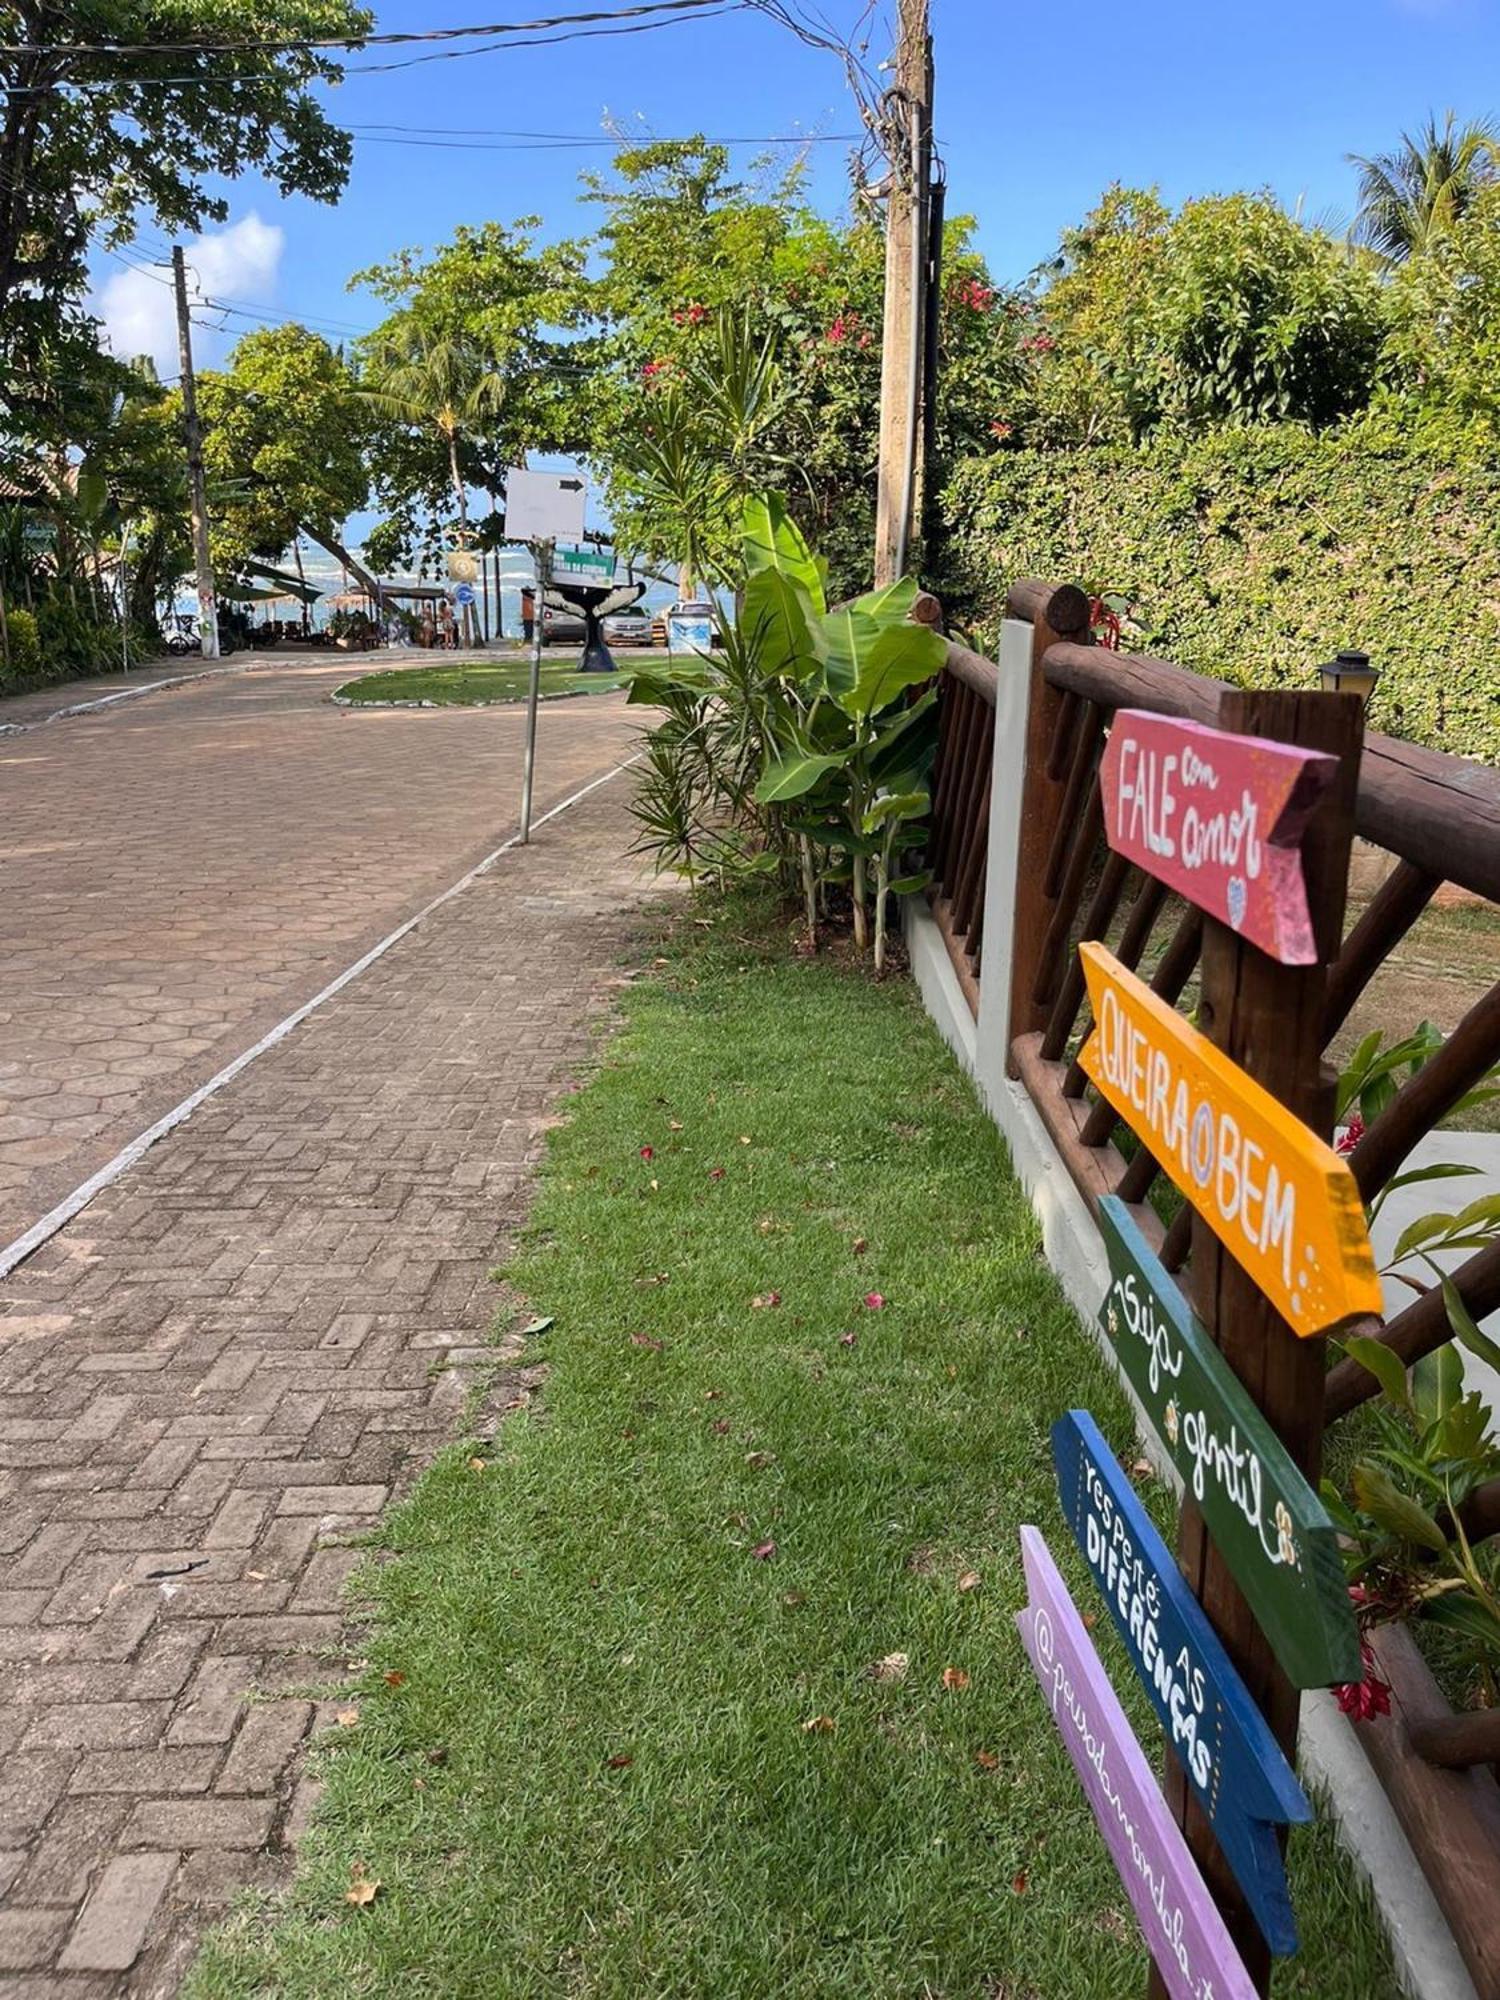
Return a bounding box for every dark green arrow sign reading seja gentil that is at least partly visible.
[1100,1196,1362,1688]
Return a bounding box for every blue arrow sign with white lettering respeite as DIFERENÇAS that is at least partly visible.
[1052,1410,1312,1954]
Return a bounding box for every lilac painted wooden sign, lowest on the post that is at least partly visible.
[1016,1528,1256,2000]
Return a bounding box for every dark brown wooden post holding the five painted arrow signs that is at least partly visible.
[1148,690,1364,2000]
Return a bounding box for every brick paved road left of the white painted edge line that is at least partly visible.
[0,654,638,1246]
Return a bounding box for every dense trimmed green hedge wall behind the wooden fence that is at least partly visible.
[936,418,1500,762]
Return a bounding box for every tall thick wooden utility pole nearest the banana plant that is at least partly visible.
[874,0,932,588]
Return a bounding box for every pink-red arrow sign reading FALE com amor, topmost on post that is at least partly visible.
[1100,708,1338,966]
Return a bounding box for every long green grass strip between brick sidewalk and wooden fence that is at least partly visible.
[188,908,1396,2000]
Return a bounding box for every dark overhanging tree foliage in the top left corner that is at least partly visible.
[0,0,372,404]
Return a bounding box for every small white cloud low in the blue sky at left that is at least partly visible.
[94,214,286,376]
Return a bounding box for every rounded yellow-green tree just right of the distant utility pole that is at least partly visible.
[198,324,372,588]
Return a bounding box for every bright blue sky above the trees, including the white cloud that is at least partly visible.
[96,0,1500,560]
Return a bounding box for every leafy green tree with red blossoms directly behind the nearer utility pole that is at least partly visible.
[586,138,1020,596]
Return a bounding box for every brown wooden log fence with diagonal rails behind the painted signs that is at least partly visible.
[930,582,1500,1996]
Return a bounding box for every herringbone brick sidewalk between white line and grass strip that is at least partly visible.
[0,772,664,2000]
